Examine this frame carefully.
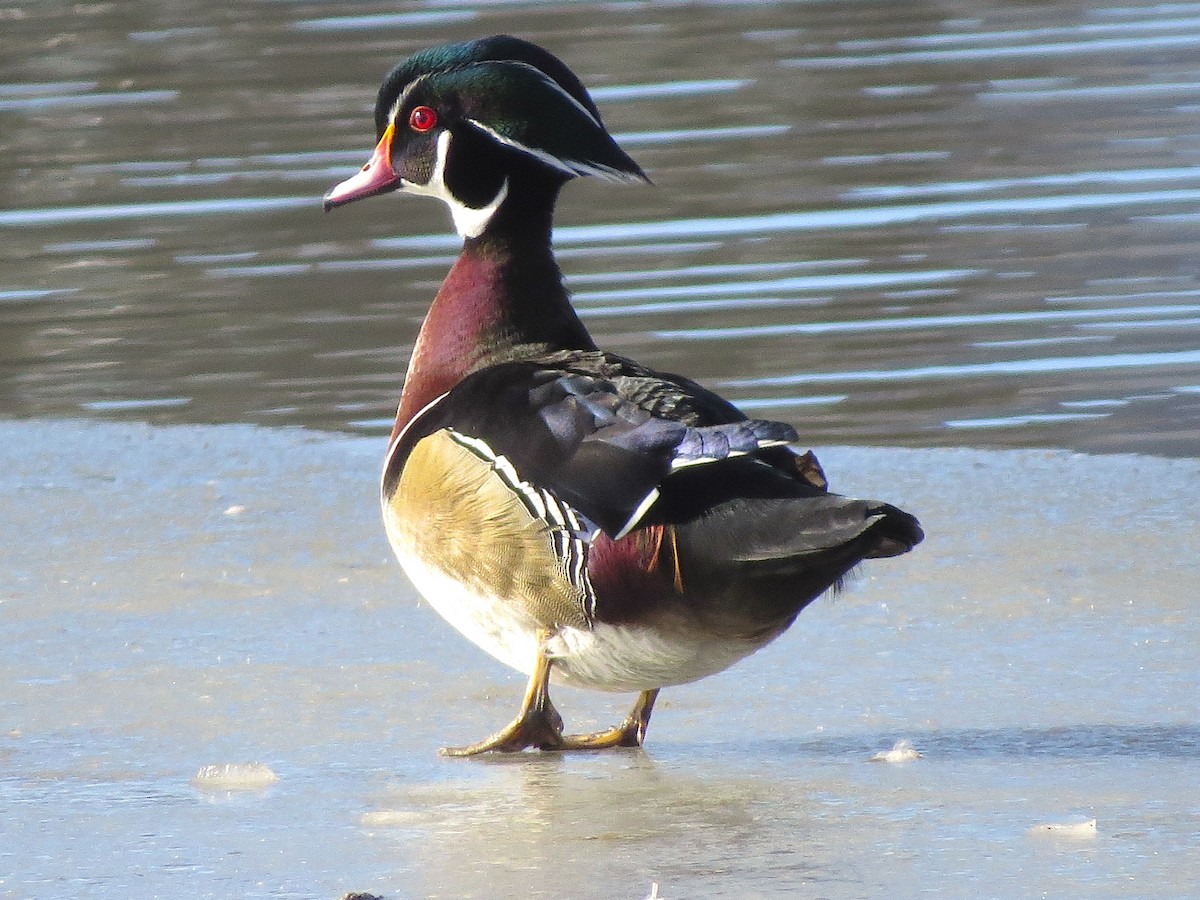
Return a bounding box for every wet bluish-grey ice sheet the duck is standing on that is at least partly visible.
[0,421,1200,900]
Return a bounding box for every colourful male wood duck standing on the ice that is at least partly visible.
[325,35,923,756]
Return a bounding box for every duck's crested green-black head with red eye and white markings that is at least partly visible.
[325,35,647,238]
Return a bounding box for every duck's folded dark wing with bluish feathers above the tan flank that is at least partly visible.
[385,362,797,538]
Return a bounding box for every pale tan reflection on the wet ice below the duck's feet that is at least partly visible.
[362,752,840,900]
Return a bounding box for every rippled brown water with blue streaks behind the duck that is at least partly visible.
[0,1,1200,455]
